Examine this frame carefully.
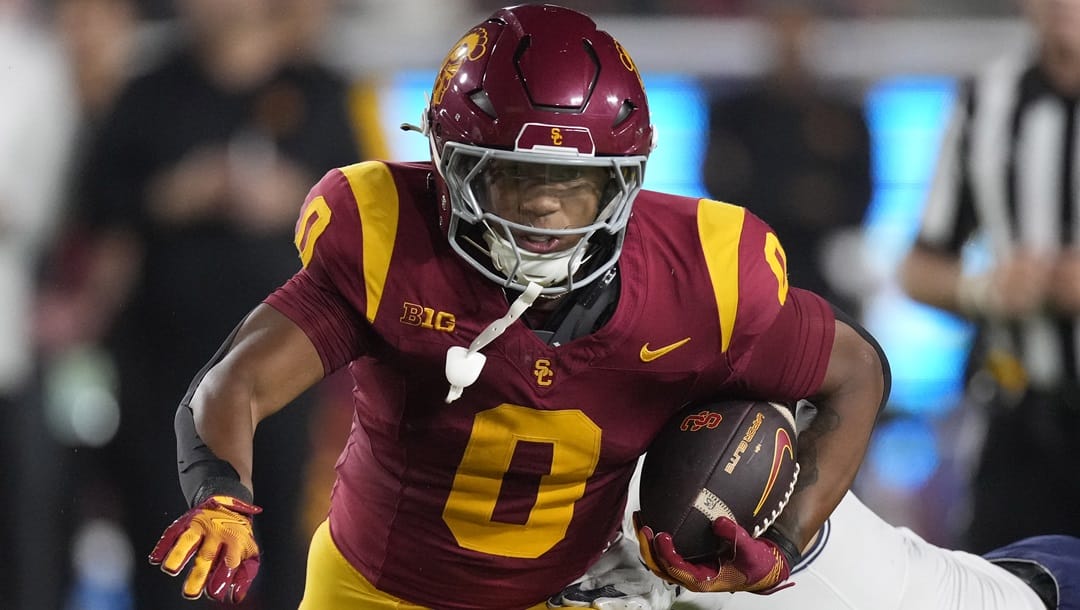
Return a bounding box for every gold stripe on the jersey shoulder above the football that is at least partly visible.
[698,199,746,352]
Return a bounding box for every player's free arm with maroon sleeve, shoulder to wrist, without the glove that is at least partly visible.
[176,164,373,504]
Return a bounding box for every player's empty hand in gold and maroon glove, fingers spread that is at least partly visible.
[150,496,262,604]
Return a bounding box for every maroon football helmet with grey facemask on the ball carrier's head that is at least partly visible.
[423,4,653,295]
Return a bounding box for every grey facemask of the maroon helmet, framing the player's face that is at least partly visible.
[438,143,646,296]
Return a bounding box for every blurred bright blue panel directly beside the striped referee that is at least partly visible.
[864,77,971,416]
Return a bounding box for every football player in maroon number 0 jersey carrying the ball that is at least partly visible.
[150,4,888,610]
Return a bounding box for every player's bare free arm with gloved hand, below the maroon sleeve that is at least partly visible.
[150,304,324,601]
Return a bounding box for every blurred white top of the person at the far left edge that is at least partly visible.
[0,0,78,399]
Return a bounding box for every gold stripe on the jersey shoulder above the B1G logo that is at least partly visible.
[341,161,399,323]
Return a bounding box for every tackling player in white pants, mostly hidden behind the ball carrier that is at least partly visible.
[553,446,1080,610]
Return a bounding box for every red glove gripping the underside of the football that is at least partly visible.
[634,513,791,593]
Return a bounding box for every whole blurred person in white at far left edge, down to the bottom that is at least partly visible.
[0,0,77,608]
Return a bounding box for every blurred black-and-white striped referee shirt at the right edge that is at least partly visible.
[917,48,1080,389]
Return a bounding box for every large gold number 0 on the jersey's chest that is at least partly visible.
[443,405,600,558]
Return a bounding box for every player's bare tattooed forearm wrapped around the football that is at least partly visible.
[774,324,888,548]
